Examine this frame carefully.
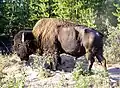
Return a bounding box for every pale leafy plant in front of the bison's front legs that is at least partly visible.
[31,56,53,79]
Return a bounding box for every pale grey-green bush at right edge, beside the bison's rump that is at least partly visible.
[104,27,120,63]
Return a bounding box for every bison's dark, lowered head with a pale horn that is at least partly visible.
[13,30,37,61]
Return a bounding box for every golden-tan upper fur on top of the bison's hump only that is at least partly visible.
[32,18,75,38]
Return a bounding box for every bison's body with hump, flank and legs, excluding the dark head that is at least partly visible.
[32,18,106,70]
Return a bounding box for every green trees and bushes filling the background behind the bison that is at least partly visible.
[0,0,120,88]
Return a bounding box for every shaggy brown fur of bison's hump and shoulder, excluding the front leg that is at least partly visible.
[32,18,75,53]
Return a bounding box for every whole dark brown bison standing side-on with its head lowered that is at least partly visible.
[14,18,106,70]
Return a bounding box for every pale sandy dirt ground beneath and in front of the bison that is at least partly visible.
[3,54,120,88]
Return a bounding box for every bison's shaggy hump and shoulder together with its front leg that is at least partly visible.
[32,18,75,70]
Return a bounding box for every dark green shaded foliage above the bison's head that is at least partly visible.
[1,0,29,33]
